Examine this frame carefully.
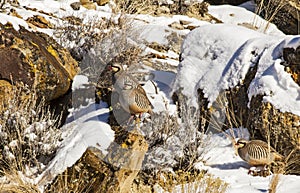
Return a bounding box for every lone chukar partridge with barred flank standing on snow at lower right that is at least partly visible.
[235,139,283,166]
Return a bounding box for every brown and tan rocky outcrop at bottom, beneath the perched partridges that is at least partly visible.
[46,128,148,193]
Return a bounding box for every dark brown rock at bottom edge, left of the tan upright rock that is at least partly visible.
[45,148,114,193]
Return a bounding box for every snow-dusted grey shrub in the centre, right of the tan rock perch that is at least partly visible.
[141,92,211,171]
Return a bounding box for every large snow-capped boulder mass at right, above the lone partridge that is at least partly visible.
[174,24,300,172]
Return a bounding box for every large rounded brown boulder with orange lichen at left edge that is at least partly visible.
[0,25,79,101]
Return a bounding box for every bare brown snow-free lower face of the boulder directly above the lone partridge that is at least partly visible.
[248,96,300,159]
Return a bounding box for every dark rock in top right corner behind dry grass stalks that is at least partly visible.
[255,0,300,35]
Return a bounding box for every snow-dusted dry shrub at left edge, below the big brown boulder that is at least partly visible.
[0,85,61,178]
